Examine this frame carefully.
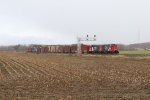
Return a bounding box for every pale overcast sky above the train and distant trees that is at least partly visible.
[0,0,150,45]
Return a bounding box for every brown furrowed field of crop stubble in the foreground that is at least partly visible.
[0,52,150,100]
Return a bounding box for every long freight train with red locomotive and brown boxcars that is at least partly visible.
[27,44,119,54]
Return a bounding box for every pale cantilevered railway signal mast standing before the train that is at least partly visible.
[77,34,96,55]
